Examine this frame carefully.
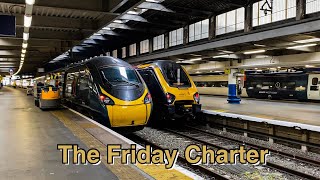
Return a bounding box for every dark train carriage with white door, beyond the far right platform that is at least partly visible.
[245,72,320,100]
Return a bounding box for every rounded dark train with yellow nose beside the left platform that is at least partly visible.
[63,57,152,131]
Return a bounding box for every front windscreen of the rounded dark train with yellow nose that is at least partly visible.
[101,67,141,85]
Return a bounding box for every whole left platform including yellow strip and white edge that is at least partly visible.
[0,87,201,179]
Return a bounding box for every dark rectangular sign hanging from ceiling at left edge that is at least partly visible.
[0,15,16,36]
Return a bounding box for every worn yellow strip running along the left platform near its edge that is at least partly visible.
[52,111,192,180]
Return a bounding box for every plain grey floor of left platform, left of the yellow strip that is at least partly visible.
[0,87,117,179]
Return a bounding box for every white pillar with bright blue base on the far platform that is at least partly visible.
[228,69,241,104]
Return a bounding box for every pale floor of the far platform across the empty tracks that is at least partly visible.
[201,95,320,126]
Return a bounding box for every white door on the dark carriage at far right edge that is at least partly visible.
[308,74,320,100]
